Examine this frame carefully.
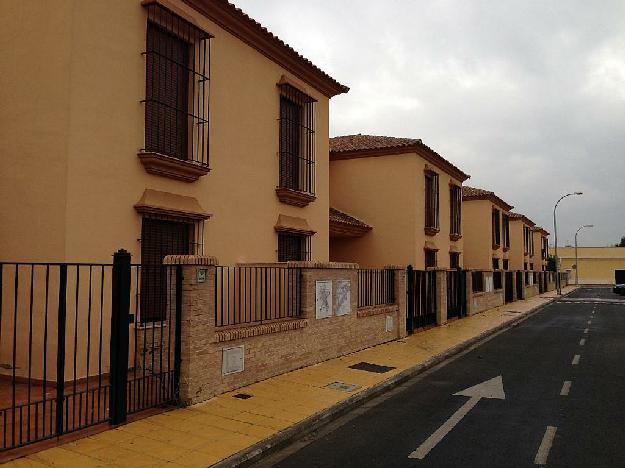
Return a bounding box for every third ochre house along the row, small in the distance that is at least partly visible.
[462,186,513,270]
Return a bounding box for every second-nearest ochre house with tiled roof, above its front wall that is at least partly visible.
[330,135,469,269]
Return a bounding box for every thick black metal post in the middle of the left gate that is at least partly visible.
[109,249,130,424]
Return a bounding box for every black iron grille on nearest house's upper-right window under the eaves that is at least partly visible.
[278,84,316,195]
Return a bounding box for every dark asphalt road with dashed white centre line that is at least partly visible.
[259,288,625,468]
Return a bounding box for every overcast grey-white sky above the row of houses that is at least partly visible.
[234,0,625,245]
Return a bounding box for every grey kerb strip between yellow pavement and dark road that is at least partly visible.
[210,288,577,468]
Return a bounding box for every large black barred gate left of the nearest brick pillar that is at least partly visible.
[0,251,182,451]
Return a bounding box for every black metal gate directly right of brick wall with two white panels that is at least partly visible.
[406,266,436,333]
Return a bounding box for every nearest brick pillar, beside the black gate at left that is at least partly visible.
[164,255,217,405]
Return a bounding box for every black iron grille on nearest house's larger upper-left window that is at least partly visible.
[142,3,211,166]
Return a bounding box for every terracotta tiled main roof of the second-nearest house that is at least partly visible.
[330,133,470,181]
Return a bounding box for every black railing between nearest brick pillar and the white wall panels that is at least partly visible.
[215,266,302,327]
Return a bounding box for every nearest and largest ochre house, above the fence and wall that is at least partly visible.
[0,0,347,264]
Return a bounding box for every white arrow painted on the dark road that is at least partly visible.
[408,375,506,460]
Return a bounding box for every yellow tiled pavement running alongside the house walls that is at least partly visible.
[7,286,573,468]
